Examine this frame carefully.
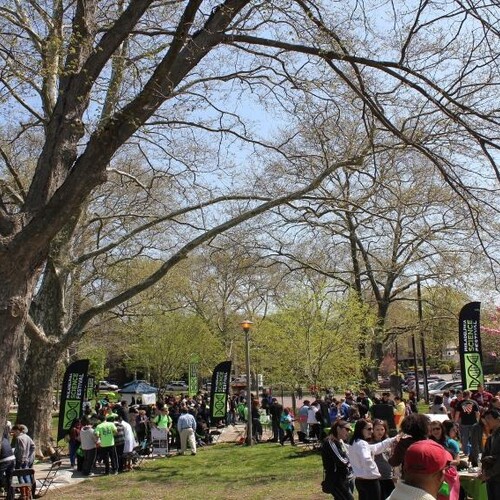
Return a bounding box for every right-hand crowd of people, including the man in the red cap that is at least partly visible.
[316,386,500,500]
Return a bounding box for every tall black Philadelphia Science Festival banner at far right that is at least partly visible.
[458,302,484,391]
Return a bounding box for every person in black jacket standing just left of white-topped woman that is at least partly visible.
[321,420,354,500]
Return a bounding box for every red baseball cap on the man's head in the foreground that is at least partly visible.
[404,439,453,474]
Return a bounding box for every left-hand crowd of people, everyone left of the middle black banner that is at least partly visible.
[0,393,219,490]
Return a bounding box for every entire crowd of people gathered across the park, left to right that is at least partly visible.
[0,380,500,500]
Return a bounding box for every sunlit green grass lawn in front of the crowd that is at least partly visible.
[46,443,331,500]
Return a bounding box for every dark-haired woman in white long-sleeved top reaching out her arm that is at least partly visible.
[348,418,399,500]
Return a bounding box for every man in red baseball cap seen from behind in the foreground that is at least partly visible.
[388,439,453,500]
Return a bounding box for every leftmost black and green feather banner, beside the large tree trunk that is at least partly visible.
[57,359,89,441]
